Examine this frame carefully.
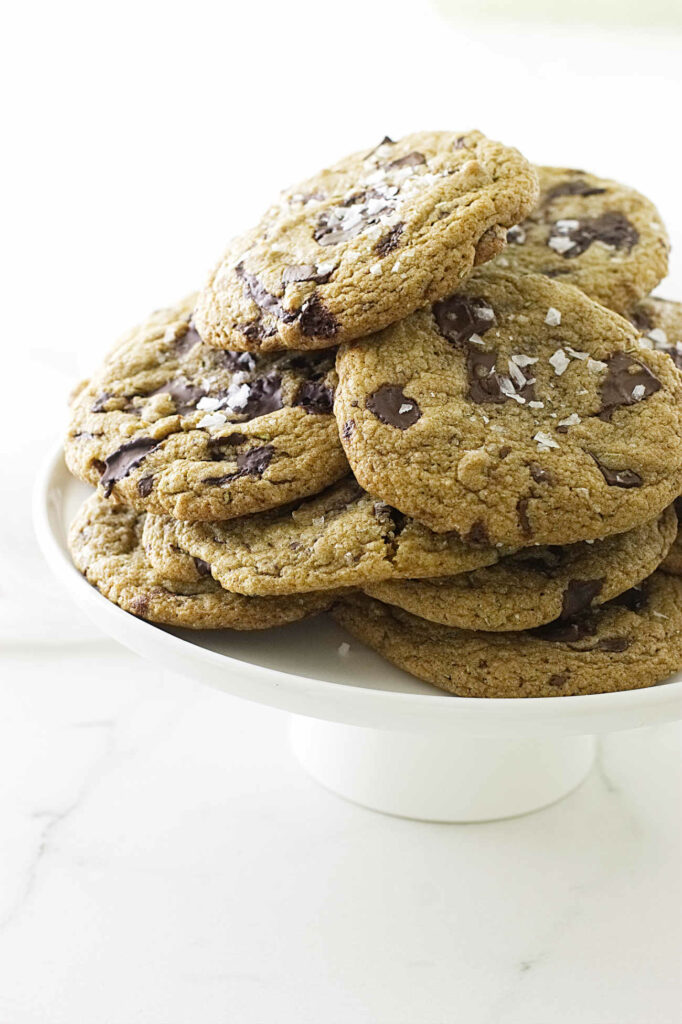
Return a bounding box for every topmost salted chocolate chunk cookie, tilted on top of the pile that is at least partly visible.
[195,131,538,351]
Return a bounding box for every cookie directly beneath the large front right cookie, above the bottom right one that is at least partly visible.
[363,505,677,632]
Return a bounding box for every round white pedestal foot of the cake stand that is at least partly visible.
[291,715,596,822]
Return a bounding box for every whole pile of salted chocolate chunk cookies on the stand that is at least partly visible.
[66,131,682,697]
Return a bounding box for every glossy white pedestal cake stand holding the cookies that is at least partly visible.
[34,451,682,821]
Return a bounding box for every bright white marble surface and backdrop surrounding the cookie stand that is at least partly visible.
[0,0,682,1024]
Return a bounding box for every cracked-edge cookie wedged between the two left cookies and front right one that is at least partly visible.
[144,477,504,595]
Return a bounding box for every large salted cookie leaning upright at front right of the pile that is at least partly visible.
[335,266,682,547]
